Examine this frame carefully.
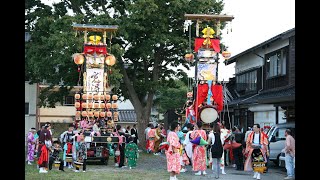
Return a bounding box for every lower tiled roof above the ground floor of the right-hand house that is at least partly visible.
[228,86,295,106]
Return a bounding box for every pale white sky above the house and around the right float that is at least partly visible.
[42,0,295,81]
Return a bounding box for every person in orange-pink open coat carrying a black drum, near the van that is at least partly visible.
[244,124,269,179]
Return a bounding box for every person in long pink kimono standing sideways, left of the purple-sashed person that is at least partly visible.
[165,122,181,180]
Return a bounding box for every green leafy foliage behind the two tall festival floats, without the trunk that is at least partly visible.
[25,0,223,112]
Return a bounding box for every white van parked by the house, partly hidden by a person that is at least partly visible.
[267,122,295,165]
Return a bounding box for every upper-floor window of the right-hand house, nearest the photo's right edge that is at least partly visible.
[266,47,288,78]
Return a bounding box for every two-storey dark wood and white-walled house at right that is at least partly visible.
[225,28,295,130]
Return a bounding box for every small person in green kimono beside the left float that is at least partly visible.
[125,136,139,169]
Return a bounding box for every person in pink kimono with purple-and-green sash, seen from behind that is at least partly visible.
[191,121,207,175]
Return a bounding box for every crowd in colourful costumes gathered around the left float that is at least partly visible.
[26,118,139,173]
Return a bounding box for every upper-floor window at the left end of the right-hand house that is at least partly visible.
[236,70,257,91]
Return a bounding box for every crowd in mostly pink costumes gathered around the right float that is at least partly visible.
[152,121,282,180]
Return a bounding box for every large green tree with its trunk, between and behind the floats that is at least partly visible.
[27,0,223,147]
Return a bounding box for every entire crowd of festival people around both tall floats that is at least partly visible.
[27,117,294,180]
